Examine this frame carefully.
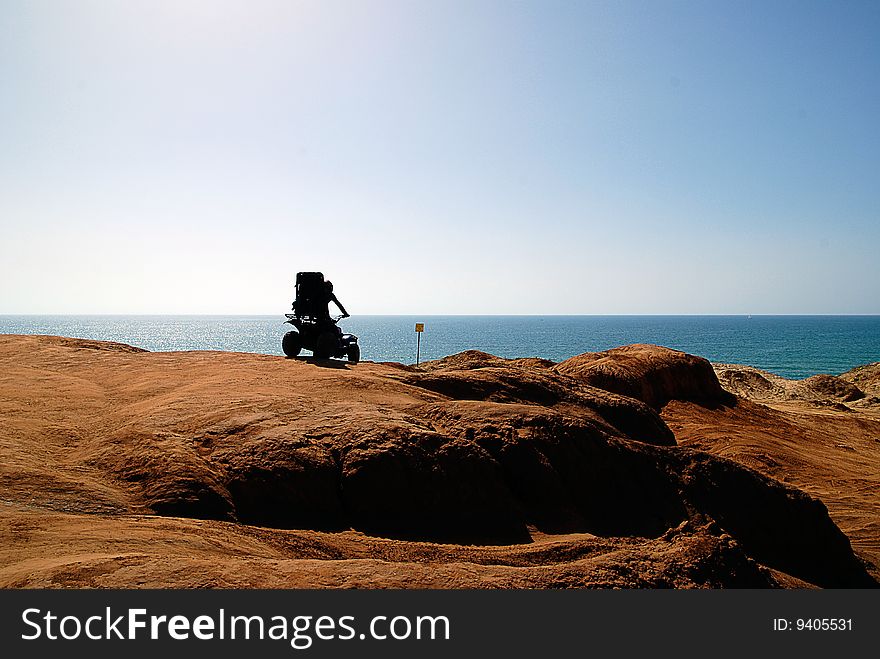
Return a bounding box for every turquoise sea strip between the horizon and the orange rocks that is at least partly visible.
[0,315,880,378]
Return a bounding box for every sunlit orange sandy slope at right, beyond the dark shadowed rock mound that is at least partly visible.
[662,364,880,576]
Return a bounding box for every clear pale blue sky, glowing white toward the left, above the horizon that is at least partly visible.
[0,0,880,314]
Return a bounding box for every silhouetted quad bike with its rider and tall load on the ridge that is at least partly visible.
[281,272,361,364]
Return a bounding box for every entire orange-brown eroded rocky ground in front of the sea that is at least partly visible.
[0,336,880,588]
